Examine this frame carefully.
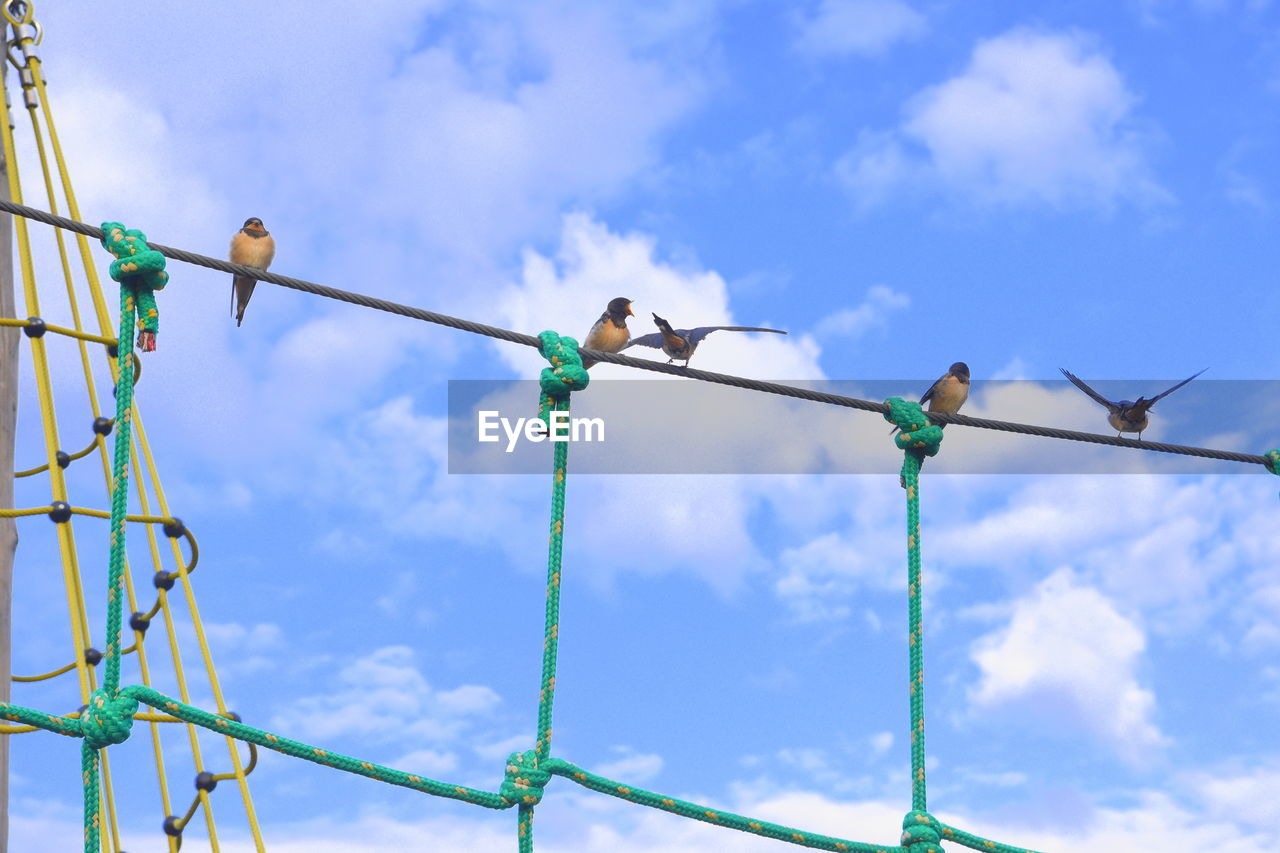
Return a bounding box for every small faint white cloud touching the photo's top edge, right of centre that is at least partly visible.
[796,0,927,59]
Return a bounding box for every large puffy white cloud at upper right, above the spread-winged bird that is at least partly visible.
[836,29,1169,209]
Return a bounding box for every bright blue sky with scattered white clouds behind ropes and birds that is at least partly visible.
[2,0,1280,853]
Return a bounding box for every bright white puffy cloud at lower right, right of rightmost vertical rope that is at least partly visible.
[969,569,1165,758]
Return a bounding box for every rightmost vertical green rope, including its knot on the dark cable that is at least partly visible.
[884,397,942,814]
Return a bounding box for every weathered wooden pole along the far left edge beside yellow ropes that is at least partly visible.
[0,28,22,853]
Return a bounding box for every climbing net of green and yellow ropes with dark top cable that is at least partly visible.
[0,3,1280,853]
